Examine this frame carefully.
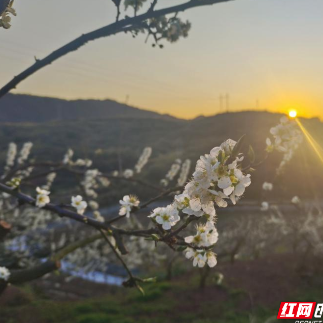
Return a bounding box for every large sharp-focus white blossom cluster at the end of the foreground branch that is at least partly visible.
[149,139,251,267]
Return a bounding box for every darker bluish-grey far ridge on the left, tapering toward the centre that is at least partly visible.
[0,94,175,122]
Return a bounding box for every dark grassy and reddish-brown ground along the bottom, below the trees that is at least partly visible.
[0,255,323,323]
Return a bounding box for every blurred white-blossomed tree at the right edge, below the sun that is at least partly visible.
[261,119,323,262]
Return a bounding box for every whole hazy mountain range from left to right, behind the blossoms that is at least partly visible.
[0,95,323,200]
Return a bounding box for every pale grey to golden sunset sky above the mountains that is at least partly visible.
[0,0,323,119]
